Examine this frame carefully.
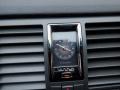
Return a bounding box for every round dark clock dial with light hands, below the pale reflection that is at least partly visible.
[53,40,76,60]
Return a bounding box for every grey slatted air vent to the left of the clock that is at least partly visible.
[0,25,45,90]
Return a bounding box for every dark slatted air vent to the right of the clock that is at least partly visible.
[86,22,120,90]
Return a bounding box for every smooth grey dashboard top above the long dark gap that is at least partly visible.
[0,0,120,15]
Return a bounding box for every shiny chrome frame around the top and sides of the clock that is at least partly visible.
[47,23,83,80]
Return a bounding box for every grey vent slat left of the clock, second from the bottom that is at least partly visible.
[0,74,45,84]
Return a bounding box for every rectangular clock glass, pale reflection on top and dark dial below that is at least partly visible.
[52,31,77,66]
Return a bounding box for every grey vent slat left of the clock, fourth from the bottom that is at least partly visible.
[0,54,44,65]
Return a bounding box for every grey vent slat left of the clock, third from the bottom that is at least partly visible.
[0,63,45,74]
